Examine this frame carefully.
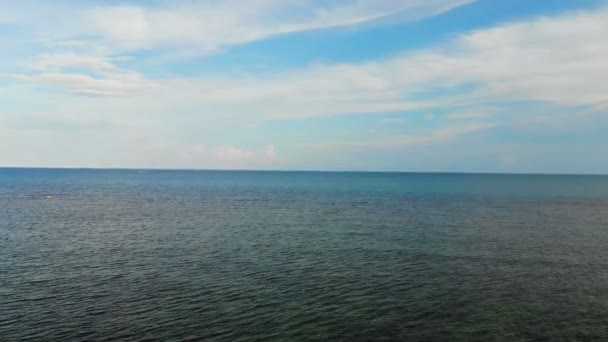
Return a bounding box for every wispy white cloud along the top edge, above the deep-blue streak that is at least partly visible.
[0,0,476,56]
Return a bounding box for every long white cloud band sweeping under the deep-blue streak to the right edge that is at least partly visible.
[15,4,608,119]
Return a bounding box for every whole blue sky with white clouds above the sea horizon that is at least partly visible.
[0,0,608,174]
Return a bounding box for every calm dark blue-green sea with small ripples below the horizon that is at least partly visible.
[0,169,608,341]
